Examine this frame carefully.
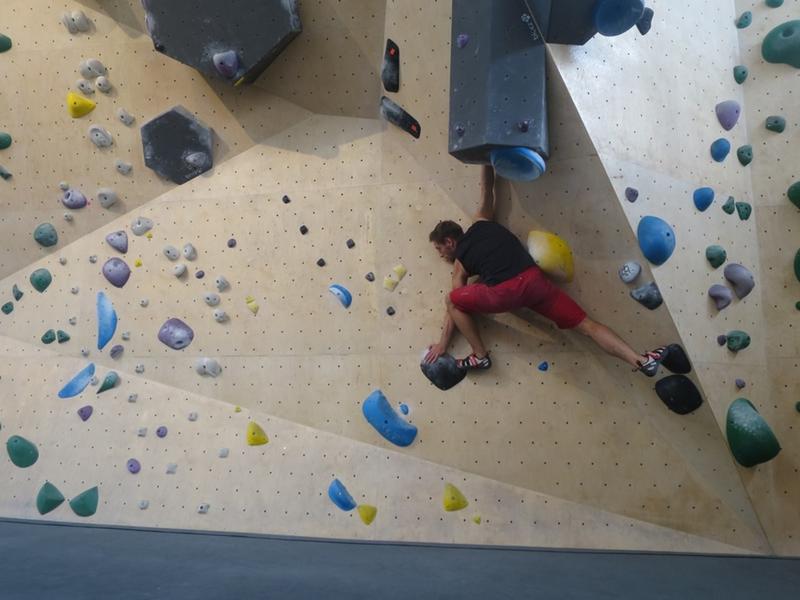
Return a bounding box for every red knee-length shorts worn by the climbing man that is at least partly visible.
[450,267,586,329]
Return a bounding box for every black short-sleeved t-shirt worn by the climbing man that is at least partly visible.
[456,221,536,286]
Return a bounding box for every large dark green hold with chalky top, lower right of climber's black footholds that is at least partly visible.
[725,398,781,467]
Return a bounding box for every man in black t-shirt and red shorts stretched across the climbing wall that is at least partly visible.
[425,167,667,377]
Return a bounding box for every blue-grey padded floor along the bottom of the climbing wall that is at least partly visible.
[0,520,800,600]
